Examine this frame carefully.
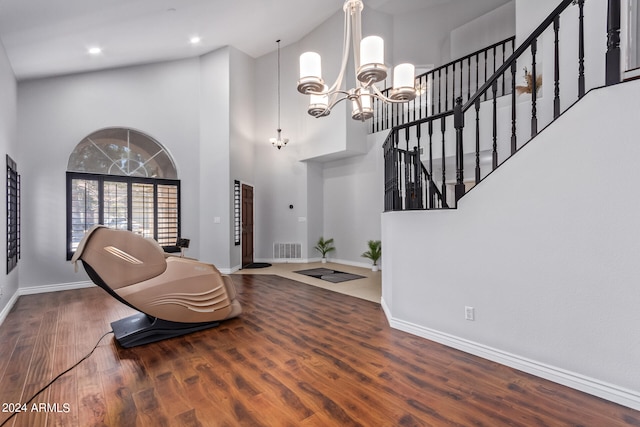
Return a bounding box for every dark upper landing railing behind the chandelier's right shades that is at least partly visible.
[370,37,515,133]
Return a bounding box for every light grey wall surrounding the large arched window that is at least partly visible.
[16,58,202,288]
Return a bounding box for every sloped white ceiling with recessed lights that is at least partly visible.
[0,0,451,80]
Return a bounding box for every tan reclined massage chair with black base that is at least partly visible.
[71,225,242,347]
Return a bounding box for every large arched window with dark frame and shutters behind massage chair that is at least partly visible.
[67,128,180,259]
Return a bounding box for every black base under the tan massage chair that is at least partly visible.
[111,313,220,348]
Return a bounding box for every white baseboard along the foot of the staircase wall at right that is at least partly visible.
[380,298,640,410]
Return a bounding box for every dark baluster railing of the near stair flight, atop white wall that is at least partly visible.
[383,0,620,211]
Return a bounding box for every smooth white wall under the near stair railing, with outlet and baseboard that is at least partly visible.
[382,78,640,409]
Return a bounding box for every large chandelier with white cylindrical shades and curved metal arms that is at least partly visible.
[298,0,416,121]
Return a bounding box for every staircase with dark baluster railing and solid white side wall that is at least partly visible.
[381,0,640,414]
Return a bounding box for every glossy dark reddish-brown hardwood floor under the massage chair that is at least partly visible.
[0,275,640,427]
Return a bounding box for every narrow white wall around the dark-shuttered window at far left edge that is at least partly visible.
[0,38,18,316]
